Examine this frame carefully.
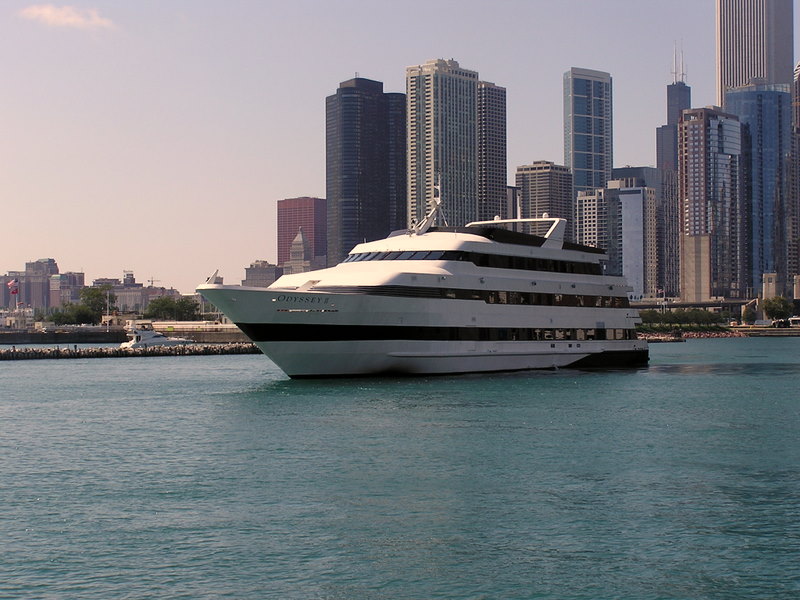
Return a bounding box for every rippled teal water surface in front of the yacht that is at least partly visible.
[0,338,800,599]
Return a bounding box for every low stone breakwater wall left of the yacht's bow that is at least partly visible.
[0,343,261,361]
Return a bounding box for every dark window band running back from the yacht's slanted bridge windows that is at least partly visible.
[342,250,603,275]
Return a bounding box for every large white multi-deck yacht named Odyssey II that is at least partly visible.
[197,205,648,377]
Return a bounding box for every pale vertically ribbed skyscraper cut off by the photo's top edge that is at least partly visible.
[716,0,794,106]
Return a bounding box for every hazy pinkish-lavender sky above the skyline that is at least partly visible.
[0,0,797,293]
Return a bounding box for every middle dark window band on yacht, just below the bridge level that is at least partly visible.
[311,285,630,308]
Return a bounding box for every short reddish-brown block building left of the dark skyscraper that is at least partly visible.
[278,197,328,265]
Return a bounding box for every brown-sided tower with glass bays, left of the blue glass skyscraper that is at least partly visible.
[678,107,748,302]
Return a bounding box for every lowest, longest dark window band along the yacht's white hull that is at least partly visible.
[236,323,636,342]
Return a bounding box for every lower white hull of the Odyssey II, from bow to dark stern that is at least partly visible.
[200,285,648,378]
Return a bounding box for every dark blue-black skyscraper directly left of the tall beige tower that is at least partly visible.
[324,77,405,265]
